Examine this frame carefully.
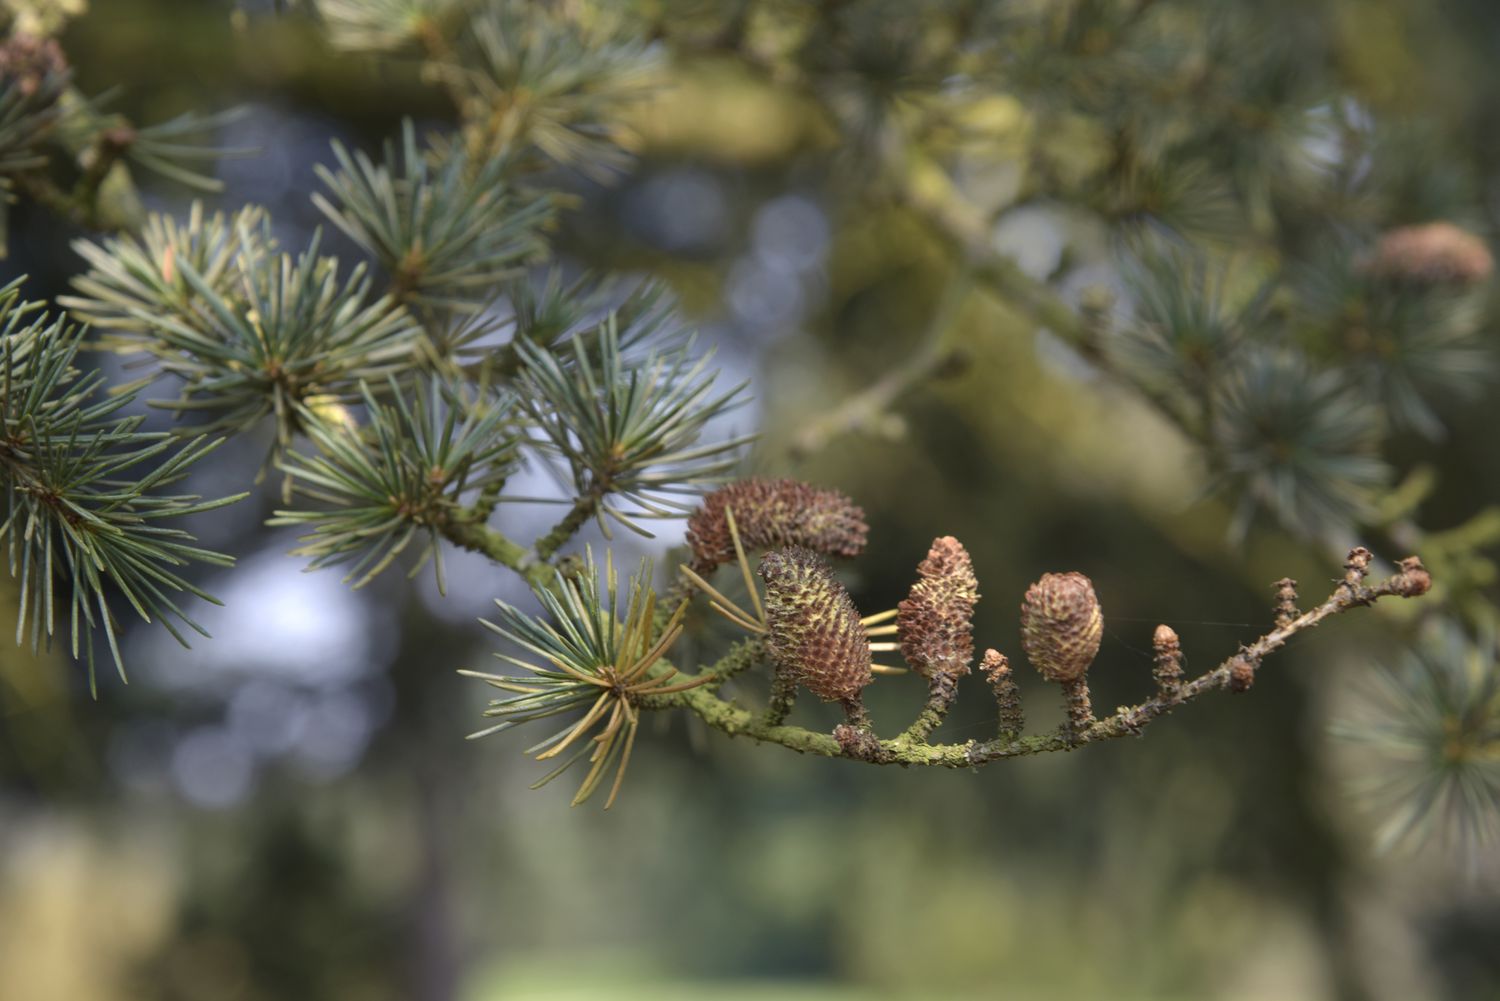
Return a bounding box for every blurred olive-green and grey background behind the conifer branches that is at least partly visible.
[0,0,1500,1001]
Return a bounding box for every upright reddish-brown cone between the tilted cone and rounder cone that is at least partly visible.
[896,536,980,678]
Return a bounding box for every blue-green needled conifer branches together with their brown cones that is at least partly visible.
[0,0,1500,864]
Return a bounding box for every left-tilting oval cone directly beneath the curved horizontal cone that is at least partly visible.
[761,548,872,702]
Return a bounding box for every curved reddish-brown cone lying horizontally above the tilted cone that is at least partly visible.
[687,479,870,573]
